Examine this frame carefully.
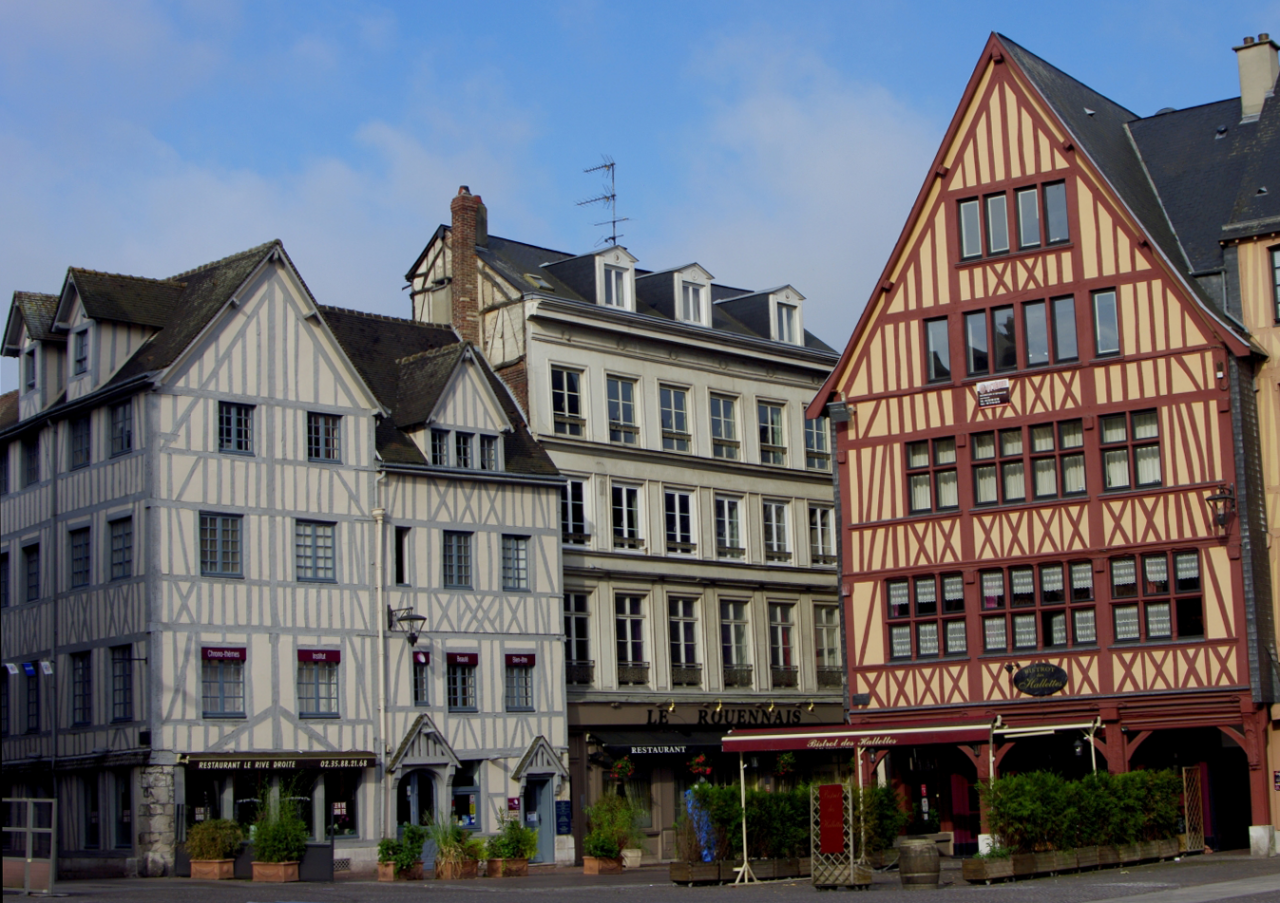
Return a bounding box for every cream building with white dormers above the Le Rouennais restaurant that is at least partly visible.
[407,188,844,858]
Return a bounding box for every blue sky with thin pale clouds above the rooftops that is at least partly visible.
[0,0,1280,391]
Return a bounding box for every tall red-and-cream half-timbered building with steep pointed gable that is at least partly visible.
[809,35,1275,849]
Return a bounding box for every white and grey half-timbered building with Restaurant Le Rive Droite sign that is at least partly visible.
[0,242,572,875]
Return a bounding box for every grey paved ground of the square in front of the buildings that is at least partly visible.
[15,853,1280,903]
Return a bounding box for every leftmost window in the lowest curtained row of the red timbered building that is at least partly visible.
[886,574,968,660]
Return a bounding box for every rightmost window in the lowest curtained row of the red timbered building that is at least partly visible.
[1111,552,1204,642]
